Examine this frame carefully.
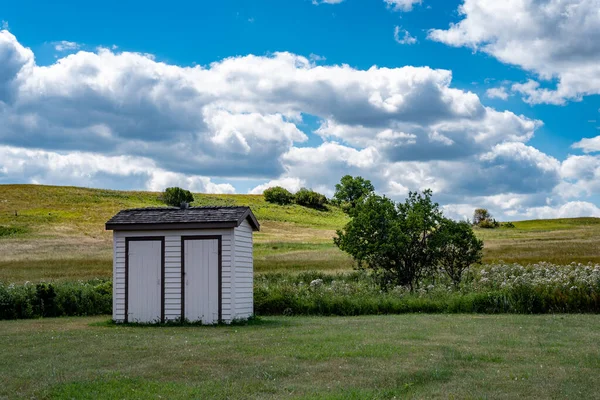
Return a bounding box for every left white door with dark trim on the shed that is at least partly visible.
[127,240,162,322]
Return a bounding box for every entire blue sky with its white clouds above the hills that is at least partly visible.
[0,0,600,219]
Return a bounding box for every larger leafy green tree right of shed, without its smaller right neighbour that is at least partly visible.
[334,190,443,291]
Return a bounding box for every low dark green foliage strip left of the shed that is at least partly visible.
[0,280,112,319]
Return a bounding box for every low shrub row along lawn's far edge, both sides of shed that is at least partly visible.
[0,263,600,319]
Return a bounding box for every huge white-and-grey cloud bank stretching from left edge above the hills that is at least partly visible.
[0,31,592,218]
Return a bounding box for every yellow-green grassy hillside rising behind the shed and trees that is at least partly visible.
[0,185,600,282]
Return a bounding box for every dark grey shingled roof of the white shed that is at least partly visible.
[106,206,260,231]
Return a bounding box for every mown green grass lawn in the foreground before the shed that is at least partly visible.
[0,314,600,399]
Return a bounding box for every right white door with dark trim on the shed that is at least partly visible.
[184,239,219,324]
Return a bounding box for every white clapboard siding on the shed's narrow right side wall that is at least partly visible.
[234,220,254,319]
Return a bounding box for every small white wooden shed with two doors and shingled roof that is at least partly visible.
[106,207,260,324]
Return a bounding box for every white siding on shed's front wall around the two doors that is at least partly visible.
[113,228,233,322]
